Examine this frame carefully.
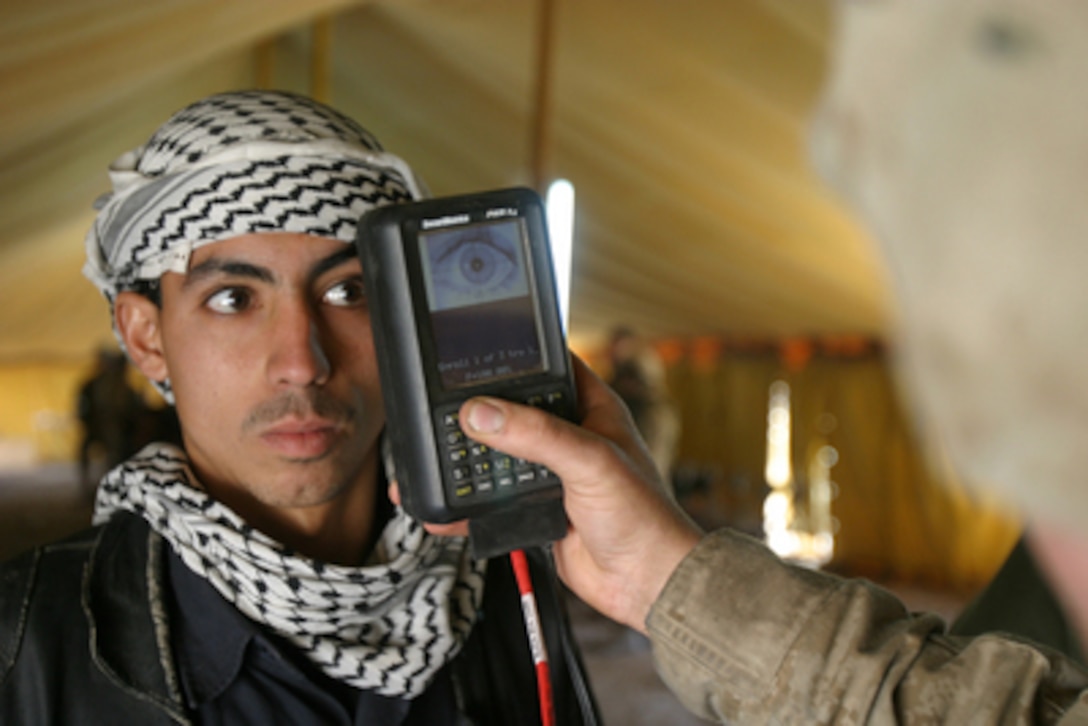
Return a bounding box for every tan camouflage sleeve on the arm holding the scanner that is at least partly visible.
[646,531,1088,724]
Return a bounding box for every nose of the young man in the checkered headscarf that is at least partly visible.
[269,300,332,386]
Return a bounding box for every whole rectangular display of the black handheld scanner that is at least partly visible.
[419,219,547,390]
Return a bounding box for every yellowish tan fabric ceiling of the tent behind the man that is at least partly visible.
[0,0,887,359]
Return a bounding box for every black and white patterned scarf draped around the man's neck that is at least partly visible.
[95,444,484,698]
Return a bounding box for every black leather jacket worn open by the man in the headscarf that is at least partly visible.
[0,513,599,726]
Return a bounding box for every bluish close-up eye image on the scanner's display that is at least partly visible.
[421,220,529,310]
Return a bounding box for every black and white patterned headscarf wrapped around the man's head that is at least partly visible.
[83,90,425,401]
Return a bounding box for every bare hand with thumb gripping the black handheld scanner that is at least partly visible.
[461,357,703,631]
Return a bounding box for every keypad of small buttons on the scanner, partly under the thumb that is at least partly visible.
[440,391,567,500]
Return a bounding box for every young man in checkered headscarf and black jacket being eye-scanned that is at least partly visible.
[0,91,594,725]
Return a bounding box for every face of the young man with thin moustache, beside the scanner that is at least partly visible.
[142,234,385,512]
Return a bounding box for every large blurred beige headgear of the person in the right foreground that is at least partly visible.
[813,0,1088,521]
